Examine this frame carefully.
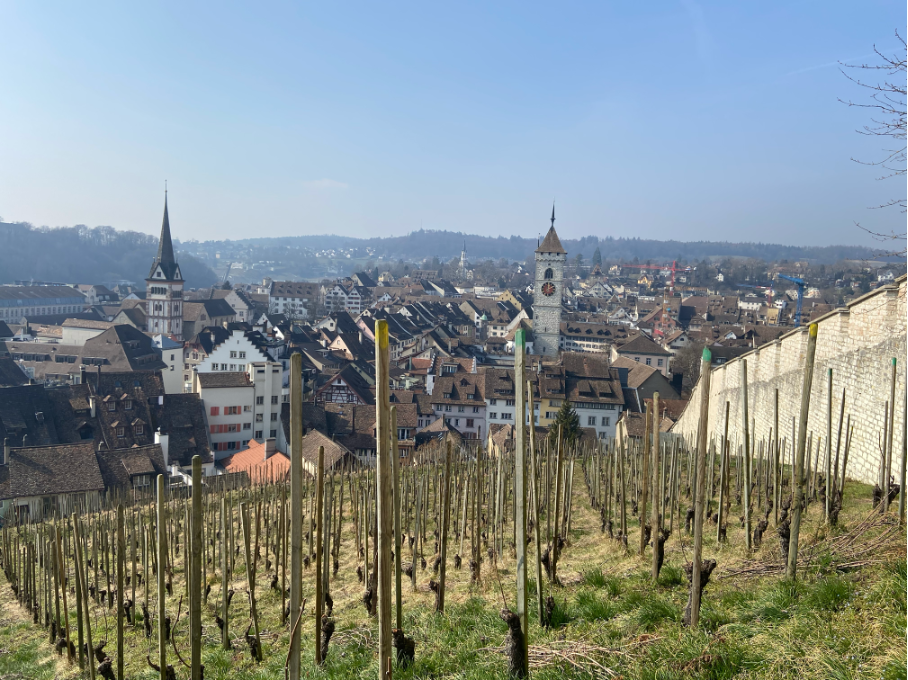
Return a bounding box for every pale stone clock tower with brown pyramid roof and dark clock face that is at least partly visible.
[533,206,567,357]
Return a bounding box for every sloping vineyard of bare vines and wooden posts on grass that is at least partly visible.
[0,322,908,680]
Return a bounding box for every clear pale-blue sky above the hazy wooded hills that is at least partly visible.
[0,0,906,245]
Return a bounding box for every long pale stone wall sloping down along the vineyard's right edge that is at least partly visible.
[672,276,908,484]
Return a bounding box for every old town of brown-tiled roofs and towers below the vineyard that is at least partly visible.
[0,198,897,516]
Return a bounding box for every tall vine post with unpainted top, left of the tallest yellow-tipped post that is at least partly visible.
[284,352,304,680]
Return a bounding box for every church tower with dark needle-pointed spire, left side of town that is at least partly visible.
[145,191,183,342]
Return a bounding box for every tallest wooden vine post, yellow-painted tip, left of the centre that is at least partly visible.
[375,321,392,680]
